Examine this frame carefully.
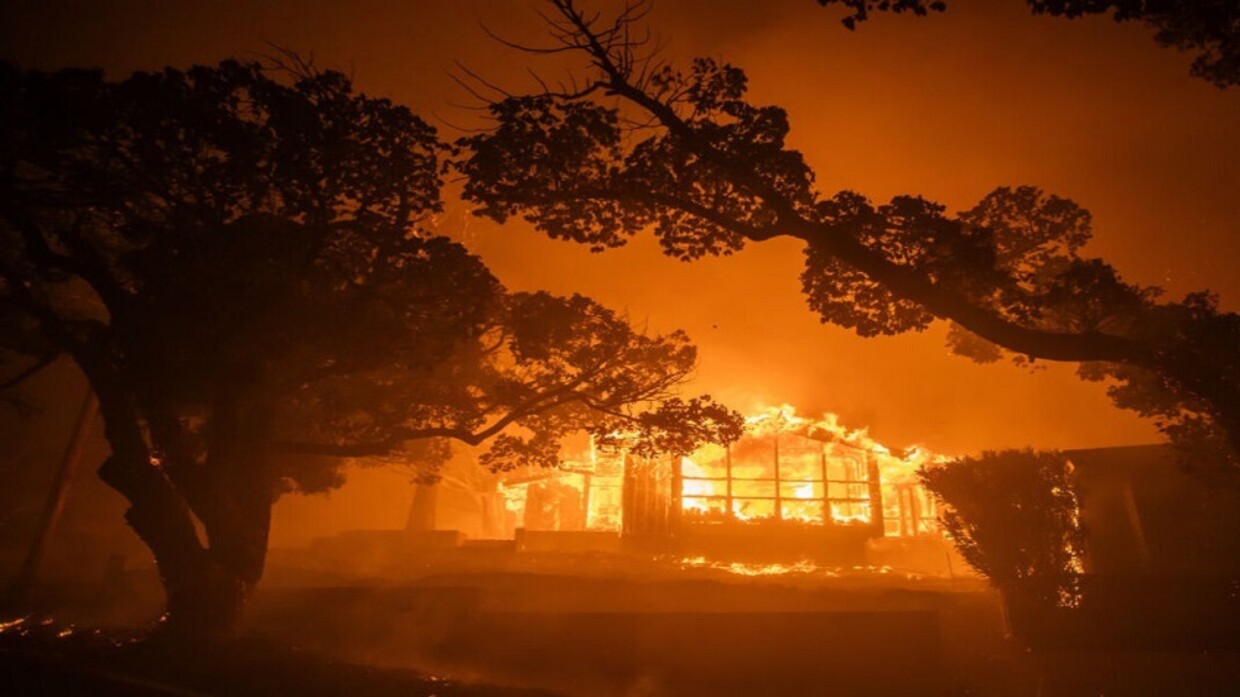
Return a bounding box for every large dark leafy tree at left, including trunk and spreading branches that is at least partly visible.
[0,60,739,640]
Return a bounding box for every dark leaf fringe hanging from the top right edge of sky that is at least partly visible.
[817,0,1240,88]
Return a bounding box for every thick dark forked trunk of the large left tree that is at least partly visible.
[11,316,275,645]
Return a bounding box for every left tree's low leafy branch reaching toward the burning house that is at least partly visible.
[275,285,743,468]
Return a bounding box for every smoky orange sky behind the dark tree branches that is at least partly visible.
[0,0,1240,540]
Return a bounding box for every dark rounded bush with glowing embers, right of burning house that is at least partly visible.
[918,450,1085,608]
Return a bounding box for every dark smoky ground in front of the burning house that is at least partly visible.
[9,552,1240,697]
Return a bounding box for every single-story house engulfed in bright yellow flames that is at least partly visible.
[410,407,937,564]
